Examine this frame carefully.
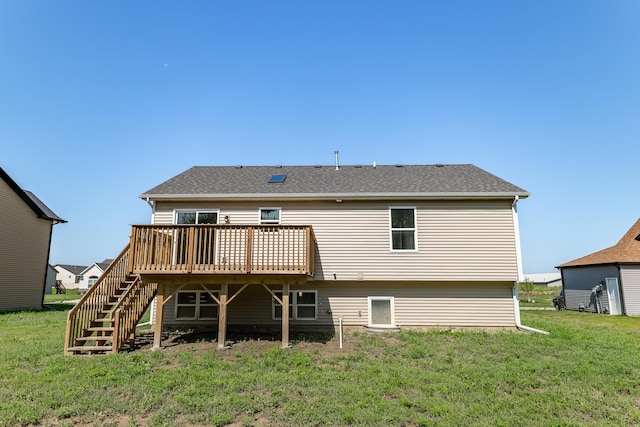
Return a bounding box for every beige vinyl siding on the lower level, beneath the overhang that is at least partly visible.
[164,282,515,327]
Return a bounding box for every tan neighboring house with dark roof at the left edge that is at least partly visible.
[0,168,66,311]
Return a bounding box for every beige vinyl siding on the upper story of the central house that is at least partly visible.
[155,201,518,281]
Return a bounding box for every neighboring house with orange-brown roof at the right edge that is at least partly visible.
[557,219,640,315]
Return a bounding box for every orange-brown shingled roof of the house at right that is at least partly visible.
[557,219,640,268]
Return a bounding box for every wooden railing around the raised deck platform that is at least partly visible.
[129,224,316,276]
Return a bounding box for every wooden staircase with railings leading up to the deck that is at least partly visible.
[64,246,158,355]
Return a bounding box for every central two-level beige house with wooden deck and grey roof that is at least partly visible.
[65,165,529,354]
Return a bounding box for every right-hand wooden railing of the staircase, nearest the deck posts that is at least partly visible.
[111,277,158,353]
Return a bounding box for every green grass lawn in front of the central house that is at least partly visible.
[0,311,640,426]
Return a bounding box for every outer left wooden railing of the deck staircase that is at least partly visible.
[64,245,129,355]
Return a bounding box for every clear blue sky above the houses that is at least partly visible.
[0,0,640,273]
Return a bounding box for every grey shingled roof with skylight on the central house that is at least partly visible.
[140,165,529,200]
